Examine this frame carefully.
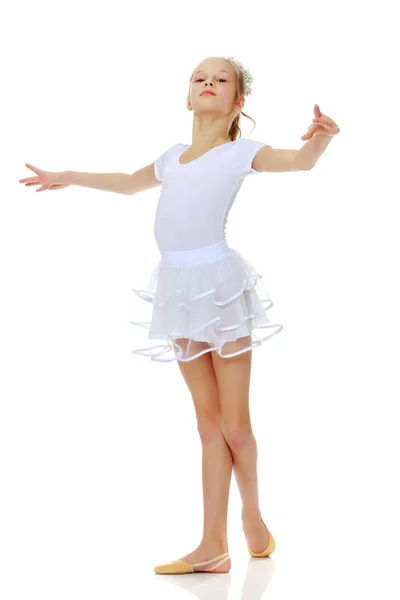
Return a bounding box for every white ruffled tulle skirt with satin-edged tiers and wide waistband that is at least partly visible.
[131,238,283,362]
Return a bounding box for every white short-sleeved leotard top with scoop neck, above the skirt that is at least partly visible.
[154,138,267,251]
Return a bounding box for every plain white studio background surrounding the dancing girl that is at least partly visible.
[0,0,400,600]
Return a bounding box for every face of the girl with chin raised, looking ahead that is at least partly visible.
[188,58,241,114]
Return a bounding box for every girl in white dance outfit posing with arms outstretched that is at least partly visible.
[20,57,339,574]
